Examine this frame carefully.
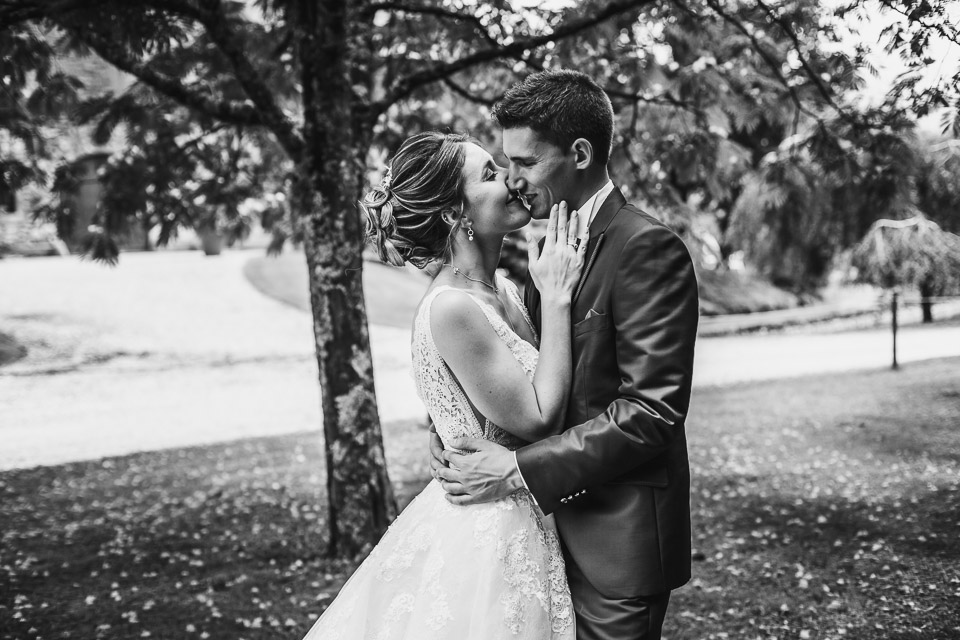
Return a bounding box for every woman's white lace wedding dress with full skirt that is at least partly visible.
[304,278,576,640]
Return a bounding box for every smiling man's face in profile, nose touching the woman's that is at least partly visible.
[503,127,579,220]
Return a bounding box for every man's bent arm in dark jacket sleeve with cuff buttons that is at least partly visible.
[517,226,699,513]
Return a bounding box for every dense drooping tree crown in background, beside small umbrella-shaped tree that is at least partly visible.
[731,114,918,291]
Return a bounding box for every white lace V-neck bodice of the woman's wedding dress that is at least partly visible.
[412,276,539,449]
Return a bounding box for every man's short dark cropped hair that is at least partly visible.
[493,69,613,165]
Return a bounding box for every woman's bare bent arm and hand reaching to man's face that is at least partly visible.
[430,205,586,442]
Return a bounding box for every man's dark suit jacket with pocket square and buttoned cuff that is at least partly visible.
[517,189,699,598]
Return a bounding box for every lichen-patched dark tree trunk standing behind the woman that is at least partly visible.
[294,0,397,557]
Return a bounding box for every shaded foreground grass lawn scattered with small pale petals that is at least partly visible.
[0,360,960,640]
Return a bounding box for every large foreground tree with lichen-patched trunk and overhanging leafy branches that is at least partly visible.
[0,0,955,555]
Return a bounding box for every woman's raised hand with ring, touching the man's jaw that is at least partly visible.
[527,202,587,303]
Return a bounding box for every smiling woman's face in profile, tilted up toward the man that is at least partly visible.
[463,143,530,235]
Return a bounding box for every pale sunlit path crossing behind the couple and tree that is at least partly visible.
[0,249,960,469]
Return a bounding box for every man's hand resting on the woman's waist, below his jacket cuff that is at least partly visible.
[437,438,523,505]
